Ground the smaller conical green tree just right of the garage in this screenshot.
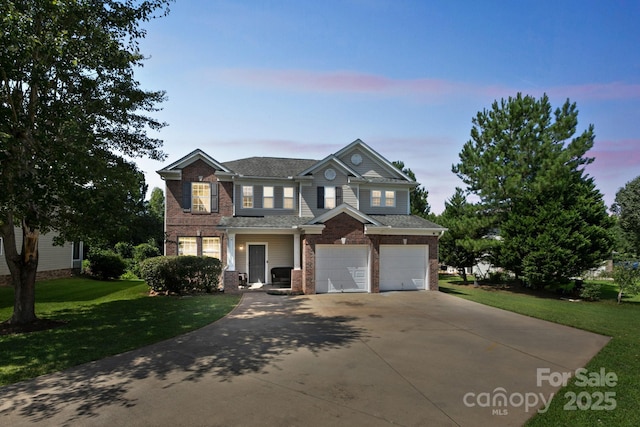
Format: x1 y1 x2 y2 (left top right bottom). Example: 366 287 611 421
437 188 498 283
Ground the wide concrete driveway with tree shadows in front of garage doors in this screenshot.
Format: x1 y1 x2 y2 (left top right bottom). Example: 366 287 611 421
0 291 609 427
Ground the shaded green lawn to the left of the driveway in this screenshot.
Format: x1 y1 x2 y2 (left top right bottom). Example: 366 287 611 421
0 277 240 385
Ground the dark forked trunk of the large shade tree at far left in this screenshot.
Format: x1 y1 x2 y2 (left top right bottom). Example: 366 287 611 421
0 218 39 324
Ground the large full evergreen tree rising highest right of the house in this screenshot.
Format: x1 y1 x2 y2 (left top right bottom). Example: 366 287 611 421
452 94 612 286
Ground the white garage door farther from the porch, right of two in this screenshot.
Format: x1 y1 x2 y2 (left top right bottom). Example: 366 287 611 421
380 245 429 291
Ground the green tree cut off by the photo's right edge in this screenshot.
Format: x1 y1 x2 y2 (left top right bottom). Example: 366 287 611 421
611 176 640 255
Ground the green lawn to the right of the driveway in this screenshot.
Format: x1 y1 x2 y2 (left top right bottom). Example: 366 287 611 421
440 277 640 426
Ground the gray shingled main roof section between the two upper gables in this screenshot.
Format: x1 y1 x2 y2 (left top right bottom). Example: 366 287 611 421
223 157 318 178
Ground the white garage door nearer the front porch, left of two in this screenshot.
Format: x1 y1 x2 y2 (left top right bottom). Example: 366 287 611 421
316 245 369 294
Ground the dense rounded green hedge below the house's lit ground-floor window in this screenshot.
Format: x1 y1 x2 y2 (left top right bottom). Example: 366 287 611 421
140 255 222 295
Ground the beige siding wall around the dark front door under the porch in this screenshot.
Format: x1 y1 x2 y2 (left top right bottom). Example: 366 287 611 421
236 234 294 282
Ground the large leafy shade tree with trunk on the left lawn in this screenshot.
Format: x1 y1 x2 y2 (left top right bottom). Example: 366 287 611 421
0 0 169 324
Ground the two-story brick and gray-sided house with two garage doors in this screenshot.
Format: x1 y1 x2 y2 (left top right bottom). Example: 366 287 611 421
158 140 445 294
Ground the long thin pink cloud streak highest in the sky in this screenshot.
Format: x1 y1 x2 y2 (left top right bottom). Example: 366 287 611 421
213 68 640 100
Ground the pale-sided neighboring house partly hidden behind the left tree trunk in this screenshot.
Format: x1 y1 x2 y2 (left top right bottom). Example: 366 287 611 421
0 228 83 286
